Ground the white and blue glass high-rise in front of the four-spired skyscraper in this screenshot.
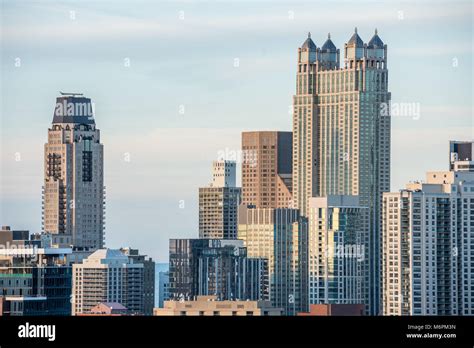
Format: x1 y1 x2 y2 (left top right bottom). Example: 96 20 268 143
308 196 369 307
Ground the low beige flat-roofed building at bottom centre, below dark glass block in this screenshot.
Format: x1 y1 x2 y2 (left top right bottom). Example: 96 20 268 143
153 296 283 316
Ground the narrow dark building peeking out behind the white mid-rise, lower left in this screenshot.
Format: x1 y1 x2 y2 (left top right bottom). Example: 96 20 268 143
120 248 155 315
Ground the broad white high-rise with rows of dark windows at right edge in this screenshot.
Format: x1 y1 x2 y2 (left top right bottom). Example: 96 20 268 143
382 163 474 315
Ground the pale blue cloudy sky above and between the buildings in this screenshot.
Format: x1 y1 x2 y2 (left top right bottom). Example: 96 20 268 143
0 0 474 262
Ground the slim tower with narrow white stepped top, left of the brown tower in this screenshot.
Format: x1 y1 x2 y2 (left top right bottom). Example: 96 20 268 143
199 161 240 239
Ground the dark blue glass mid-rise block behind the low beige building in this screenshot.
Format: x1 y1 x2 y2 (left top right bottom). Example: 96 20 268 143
169 239 269 300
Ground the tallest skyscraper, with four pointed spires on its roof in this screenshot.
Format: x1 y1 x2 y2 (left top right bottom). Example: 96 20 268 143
293 29 390 314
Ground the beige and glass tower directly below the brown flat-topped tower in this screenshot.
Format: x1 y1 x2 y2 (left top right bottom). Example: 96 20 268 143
238 205 308 315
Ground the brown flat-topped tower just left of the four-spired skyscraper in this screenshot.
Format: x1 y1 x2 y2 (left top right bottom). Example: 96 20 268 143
242 131 293 208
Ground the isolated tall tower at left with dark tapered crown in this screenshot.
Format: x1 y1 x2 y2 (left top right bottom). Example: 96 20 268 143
43 94 105 249
